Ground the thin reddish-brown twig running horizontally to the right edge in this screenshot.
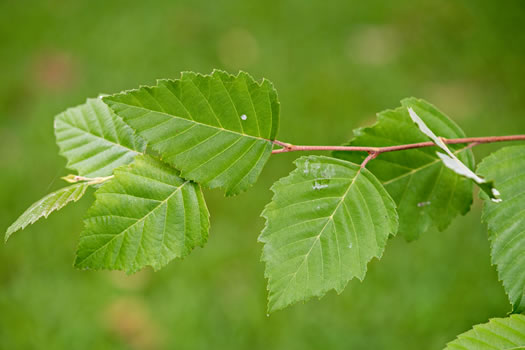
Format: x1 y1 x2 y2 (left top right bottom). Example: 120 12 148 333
272 135 525 154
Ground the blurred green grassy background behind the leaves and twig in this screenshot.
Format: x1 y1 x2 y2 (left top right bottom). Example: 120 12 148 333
0 0 525 350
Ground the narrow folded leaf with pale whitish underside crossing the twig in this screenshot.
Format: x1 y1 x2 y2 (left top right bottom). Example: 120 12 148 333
408 107 500 202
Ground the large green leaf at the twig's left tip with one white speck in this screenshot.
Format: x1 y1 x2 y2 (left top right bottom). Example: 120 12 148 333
104 71 279 195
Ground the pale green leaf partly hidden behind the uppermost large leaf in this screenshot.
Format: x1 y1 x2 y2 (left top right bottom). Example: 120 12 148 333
55 98 146 177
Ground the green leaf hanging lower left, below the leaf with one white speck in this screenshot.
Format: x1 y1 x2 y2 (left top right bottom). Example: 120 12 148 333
75 155 209 273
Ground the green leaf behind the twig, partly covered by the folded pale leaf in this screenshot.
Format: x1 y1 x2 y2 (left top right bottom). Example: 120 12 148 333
334 98 474 241
